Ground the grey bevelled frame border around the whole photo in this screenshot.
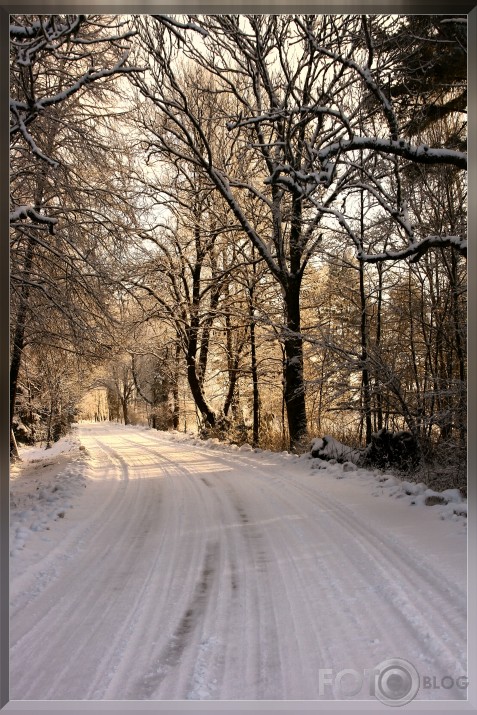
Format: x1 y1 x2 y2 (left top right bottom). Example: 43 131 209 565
0 0 477 715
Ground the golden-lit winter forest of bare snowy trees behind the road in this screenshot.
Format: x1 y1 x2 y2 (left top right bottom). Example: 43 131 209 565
10 14 467 491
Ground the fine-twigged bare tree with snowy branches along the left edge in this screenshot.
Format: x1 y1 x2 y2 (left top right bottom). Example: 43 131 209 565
10 16 143 456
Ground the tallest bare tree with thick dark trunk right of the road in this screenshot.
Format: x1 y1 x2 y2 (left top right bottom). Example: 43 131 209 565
130 16 360 447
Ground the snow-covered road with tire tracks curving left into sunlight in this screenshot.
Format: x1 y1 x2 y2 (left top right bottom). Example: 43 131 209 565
11 424 466 700
